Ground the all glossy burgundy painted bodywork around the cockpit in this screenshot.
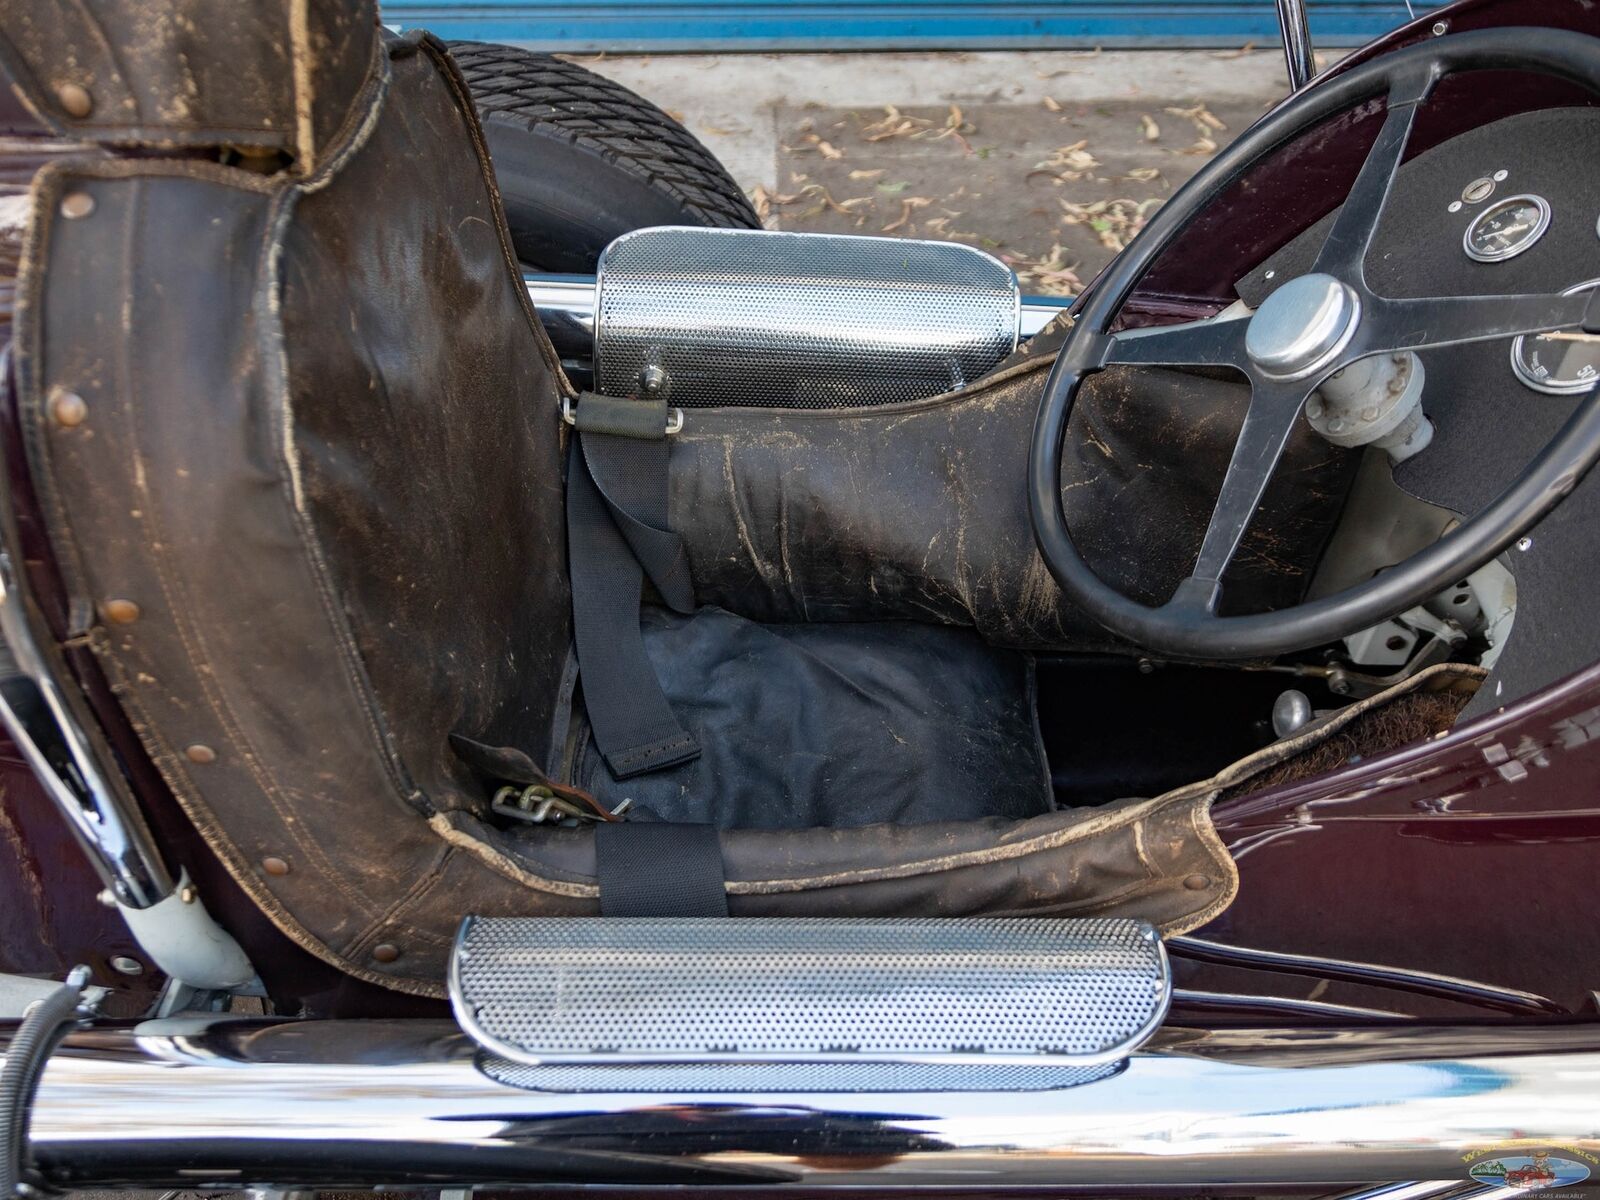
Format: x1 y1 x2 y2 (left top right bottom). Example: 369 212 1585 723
0 0 1600 1016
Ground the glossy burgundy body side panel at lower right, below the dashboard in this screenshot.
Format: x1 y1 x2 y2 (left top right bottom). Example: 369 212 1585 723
1203 666 1600 1014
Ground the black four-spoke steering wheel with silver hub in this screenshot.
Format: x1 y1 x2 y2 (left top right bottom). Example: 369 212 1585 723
1027 29 1600 659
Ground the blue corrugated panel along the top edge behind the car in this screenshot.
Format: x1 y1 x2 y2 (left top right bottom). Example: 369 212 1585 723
382 0 1432 51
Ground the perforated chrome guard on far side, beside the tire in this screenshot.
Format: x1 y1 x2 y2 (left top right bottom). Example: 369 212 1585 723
595 227 1021 408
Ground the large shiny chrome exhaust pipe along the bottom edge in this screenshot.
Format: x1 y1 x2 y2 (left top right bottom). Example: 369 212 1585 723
18 1018 1600 1195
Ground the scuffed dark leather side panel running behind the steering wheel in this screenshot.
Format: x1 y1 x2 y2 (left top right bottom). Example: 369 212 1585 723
672 358 1358 650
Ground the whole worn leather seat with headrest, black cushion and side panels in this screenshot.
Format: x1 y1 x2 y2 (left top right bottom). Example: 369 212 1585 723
0 0 1305 995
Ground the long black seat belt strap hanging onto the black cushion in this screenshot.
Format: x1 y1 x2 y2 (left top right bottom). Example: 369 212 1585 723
566 395 699 779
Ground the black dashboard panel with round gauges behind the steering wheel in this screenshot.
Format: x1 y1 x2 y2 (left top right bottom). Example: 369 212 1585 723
1238 109 1600 717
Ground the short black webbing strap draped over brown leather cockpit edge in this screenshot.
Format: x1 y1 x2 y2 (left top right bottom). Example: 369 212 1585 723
595 821 728 917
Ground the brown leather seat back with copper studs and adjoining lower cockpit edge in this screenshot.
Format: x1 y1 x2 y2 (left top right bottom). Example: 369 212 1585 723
16 16 1234 995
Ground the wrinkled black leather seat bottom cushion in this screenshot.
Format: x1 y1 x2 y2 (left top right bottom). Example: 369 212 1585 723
576 608 1051 829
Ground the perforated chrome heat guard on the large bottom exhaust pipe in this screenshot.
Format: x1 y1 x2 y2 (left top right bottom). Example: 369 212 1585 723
450 917 1171 1091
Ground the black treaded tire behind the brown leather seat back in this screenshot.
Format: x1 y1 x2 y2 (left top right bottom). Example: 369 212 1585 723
450 42 762 274
